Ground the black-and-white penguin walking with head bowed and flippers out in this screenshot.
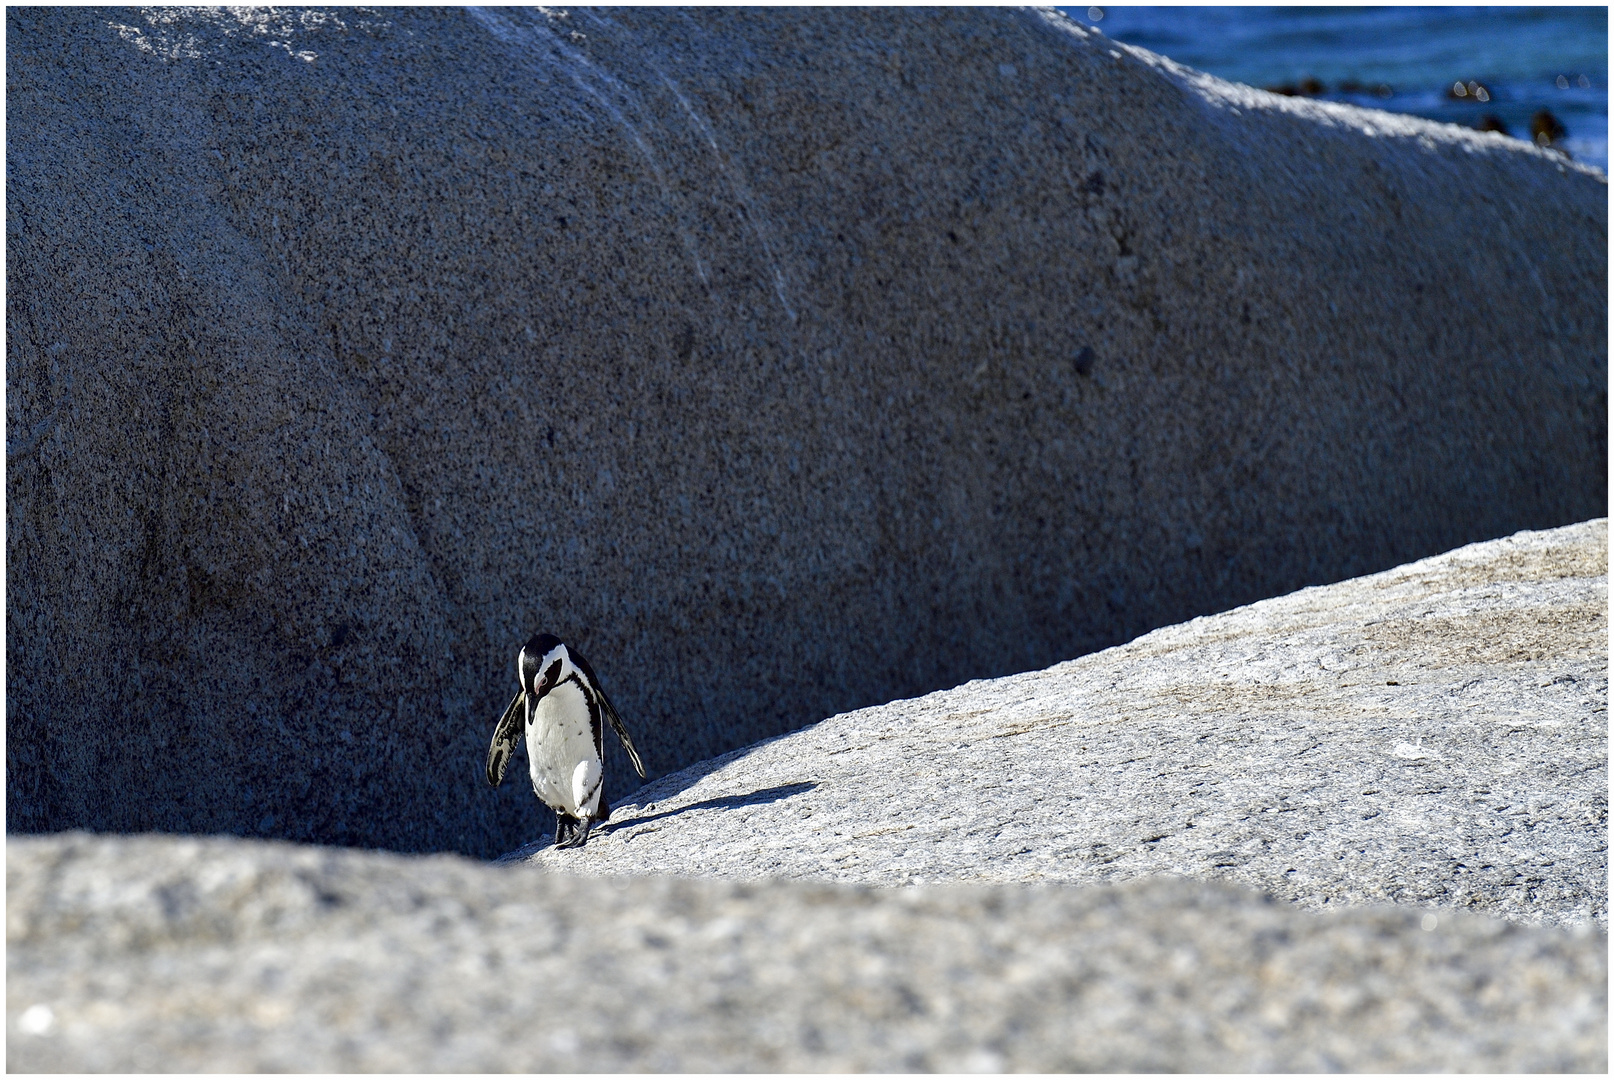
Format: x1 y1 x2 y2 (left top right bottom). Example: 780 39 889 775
487 634 644 848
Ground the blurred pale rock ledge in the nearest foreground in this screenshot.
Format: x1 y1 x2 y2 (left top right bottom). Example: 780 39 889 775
6 835 1608 1072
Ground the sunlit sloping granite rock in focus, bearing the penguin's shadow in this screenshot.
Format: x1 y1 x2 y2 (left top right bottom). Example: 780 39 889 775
512 520 1608 927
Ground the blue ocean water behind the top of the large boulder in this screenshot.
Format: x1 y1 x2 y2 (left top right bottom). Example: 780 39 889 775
1060 5 1609 171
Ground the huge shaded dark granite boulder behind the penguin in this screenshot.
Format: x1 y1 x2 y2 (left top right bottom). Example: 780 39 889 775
6 10 1606 854
